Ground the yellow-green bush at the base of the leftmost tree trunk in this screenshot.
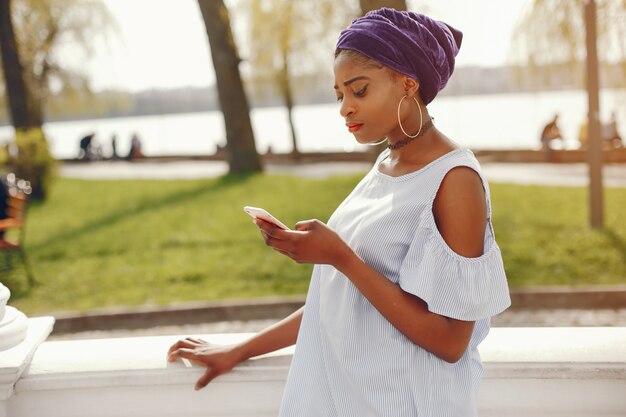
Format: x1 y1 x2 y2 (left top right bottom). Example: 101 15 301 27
0 129 56 200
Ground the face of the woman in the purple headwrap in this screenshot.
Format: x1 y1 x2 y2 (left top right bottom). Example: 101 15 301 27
334 53 404 144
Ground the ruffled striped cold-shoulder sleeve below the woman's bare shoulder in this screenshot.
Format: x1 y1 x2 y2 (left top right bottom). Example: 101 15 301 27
399 211 511 321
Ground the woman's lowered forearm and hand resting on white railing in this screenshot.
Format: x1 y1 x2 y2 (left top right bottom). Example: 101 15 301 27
168 307 304 390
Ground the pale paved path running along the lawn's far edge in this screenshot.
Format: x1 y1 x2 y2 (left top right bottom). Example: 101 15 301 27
61 160 626 187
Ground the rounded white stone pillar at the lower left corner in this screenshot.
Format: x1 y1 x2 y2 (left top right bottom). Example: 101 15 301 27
0 283 54 417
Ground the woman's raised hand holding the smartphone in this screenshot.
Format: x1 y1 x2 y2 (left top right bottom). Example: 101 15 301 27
255 219 352 267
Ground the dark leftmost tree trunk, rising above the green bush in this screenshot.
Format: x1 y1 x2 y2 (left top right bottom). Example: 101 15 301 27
0 0 43 129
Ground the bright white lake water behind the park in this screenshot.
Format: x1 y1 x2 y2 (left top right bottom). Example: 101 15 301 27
0 90 626 158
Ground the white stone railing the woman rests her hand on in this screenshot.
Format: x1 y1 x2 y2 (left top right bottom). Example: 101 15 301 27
0 319 626 417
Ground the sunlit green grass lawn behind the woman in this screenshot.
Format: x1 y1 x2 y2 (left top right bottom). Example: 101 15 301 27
0 174 626 315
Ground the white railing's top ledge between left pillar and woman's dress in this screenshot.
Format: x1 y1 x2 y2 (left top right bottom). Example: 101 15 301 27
17 333 293 392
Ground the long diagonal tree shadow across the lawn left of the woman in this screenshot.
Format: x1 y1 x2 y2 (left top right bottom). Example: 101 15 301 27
27 173 262 251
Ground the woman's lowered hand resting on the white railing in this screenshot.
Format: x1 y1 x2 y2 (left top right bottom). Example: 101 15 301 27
167 337 241 390
